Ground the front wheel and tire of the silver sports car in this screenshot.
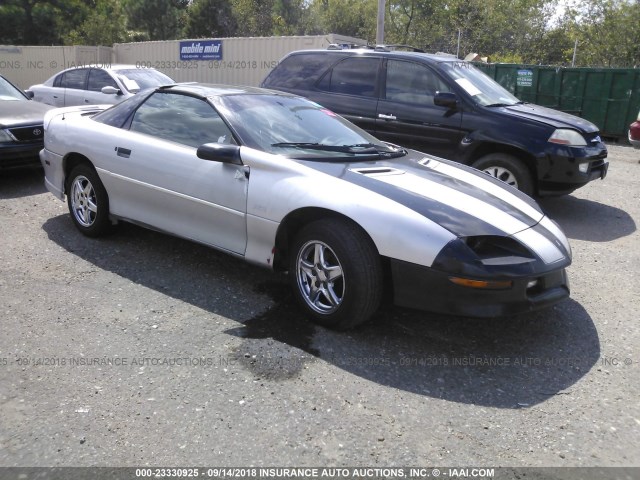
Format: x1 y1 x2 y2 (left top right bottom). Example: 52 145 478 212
289 218 383 330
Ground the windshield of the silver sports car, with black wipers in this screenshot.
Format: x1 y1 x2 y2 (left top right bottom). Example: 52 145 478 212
219 95 405 160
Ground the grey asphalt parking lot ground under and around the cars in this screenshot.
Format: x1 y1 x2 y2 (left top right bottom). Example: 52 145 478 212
0 145 640 467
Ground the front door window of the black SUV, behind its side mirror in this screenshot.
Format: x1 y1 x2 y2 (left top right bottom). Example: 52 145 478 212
385 60 450 105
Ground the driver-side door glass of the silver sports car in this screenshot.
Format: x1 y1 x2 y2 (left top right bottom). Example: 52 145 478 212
131 92 236 148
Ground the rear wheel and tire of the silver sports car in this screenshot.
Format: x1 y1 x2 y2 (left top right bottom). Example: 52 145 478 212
67 164 113 237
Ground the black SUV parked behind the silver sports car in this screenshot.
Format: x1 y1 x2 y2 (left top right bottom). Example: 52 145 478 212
261 47 609 196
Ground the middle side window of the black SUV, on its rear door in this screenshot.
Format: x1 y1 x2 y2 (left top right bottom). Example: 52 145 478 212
318 57 380 97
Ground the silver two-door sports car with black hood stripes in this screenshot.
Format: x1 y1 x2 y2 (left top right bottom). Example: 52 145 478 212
40 84 571 328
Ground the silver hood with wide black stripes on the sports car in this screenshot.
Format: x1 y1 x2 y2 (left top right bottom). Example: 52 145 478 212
300 151 544 237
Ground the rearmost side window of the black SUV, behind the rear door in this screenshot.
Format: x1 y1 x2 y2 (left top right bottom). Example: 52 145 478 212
263 52 338 89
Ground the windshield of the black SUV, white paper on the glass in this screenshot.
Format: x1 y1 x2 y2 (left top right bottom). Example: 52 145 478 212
439 62 522 107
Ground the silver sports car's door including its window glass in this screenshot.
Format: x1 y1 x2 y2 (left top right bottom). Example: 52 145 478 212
101 91 248 254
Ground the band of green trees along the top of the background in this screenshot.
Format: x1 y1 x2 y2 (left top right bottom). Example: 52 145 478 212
0 0 640 67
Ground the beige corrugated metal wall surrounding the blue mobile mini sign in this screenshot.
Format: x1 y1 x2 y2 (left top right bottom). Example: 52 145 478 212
0 34 366 89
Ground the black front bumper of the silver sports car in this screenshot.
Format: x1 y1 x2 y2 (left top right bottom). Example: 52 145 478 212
391 259 569 317
